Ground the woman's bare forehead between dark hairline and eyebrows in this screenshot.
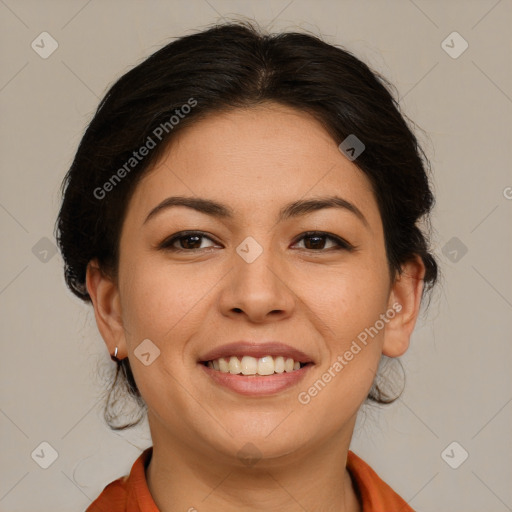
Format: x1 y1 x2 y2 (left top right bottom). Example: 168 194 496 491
124 103 379 226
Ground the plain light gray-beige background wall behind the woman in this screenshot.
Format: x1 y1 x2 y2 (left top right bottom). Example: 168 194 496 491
0 0 512 512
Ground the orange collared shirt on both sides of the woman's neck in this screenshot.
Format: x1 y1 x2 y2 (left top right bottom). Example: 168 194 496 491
85 446 414 512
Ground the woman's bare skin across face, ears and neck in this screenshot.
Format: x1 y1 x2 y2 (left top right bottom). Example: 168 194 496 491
87 103 425 512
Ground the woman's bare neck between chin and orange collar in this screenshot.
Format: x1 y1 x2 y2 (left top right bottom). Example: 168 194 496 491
146 419 362 512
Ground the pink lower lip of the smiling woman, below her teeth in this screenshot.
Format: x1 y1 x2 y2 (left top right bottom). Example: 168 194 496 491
199 363 313 396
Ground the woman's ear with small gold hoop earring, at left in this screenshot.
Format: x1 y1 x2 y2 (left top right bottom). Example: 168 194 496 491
85 259 128 359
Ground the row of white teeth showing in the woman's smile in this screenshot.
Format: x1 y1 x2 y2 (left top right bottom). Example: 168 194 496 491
207 356 301 375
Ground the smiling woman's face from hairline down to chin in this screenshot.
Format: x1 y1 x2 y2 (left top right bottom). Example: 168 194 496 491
90 104 418 464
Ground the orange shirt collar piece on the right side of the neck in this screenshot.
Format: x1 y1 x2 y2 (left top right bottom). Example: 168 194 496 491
347 450 414 512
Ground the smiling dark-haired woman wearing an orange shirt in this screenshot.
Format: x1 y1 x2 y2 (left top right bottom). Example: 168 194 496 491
58 23 437 512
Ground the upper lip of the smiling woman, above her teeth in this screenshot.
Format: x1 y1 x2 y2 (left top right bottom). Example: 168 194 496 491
199 341 313 363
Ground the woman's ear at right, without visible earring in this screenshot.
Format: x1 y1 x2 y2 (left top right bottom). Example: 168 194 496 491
382 256 425 357
